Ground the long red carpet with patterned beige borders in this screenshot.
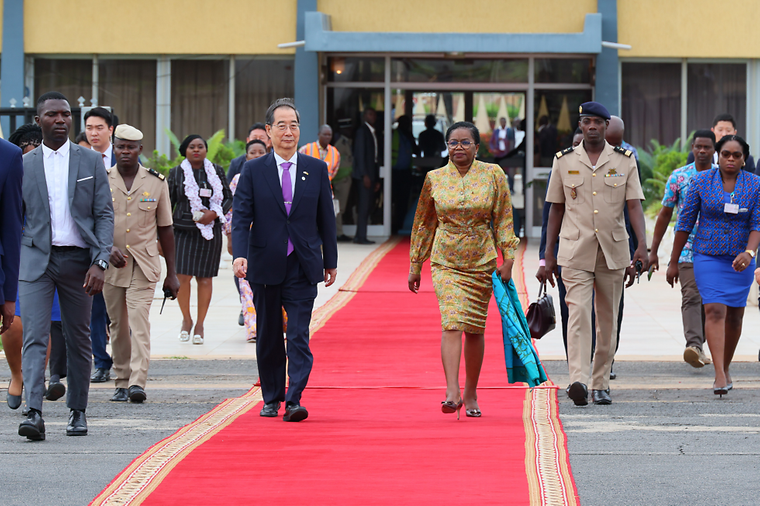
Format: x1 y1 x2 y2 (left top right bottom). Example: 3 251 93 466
93 242 577 505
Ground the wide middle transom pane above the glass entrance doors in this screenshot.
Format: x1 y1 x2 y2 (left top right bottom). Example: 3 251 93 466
391 58 528 83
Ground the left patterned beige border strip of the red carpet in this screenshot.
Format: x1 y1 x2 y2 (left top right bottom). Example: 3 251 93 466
90 238 400 506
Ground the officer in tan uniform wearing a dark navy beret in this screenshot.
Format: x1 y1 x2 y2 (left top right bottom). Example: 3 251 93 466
546 102 648 406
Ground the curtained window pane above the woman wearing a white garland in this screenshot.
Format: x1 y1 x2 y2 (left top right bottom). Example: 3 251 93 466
172 60 229 141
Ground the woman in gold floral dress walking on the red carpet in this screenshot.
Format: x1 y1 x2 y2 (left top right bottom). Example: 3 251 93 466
409 122 519 418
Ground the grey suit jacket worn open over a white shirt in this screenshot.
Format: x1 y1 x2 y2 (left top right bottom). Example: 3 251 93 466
19 143 113 281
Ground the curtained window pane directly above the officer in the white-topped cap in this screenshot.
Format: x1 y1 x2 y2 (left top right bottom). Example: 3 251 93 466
98 60 156 157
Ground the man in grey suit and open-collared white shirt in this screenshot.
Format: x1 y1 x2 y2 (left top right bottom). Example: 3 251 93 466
18 92 113 440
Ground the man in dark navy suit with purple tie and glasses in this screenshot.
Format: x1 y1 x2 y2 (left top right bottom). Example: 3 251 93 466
232 98 338 422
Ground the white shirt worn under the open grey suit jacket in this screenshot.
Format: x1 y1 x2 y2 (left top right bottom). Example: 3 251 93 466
42 141 87 248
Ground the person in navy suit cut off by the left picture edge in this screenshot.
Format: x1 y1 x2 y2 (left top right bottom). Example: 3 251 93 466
0 139 24 336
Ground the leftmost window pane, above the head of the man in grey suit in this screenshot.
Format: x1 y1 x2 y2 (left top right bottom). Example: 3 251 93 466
34 58 92 107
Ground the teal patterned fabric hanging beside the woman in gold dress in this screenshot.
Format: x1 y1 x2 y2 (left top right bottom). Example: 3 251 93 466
492 271 547 387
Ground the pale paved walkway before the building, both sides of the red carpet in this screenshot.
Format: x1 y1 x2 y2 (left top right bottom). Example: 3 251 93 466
151 238 760 361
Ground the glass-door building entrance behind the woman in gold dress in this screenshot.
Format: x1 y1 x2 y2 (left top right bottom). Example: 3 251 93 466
323 54 594 237
